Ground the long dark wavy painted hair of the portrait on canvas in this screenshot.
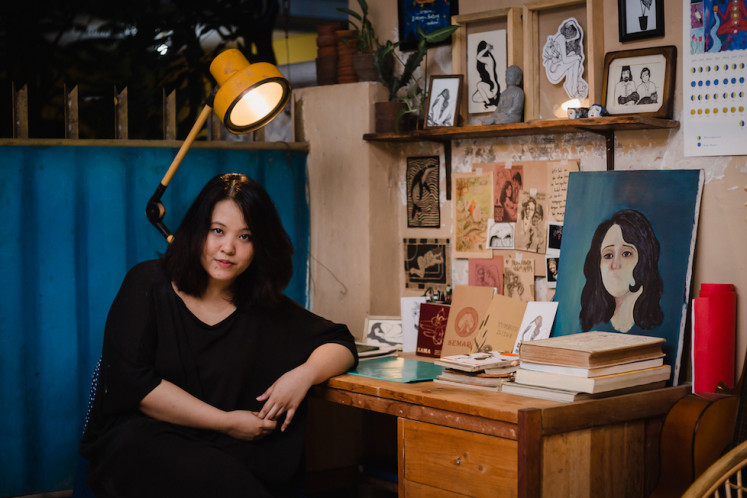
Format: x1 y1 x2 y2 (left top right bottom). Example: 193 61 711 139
579 209 664 331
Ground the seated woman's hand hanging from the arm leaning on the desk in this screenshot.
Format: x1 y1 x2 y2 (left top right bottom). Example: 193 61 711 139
257 364 313 431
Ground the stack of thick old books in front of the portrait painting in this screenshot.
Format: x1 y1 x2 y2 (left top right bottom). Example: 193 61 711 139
502 332 671 401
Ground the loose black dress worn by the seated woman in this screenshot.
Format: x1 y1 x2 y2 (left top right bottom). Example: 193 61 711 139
81 260 357 497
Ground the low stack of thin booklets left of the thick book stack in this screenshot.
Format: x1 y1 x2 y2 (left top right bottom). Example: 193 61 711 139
434 352 519 391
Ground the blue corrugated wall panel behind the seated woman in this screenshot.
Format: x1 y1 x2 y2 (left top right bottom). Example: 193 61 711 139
0 146 309 496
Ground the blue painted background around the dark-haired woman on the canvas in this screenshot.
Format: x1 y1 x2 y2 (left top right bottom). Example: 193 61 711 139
552 170 702 384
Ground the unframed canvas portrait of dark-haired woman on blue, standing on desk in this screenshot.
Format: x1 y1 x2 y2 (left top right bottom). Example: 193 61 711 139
552 170 703 383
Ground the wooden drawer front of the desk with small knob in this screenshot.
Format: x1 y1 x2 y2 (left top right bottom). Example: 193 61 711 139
399 419 518 497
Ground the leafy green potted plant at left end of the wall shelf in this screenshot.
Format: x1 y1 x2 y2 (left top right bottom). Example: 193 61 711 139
374 25 459 133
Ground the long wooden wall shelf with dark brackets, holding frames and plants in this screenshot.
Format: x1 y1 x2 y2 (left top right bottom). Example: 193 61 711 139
363 115 680 199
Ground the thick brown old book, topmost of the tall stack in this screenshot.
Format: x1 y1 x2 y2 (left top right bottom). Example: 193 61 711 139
519 331 664 368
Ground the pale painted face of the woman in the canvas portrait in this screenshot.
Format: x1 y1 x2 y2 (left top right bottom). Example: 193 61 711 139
599 225 638 297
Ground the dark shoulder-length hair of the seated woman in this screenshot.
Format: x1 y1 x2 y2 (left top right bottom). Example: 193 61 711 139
163 173 293 306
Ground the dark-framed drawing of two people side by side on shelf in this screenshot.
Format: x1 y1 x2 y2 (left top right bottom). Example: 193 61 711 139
602 45 677 119
